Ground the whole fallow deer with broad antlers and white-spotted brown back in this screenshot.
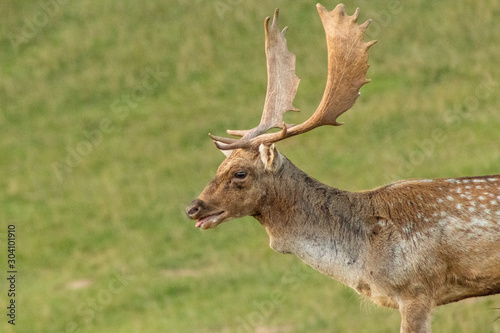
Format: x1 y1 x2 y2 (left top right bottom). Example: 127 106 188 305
186 4 500 333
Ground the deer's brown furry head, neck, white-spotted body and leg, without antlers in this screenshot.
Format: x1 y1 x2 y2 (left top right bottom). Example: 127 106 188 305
186 146 500 332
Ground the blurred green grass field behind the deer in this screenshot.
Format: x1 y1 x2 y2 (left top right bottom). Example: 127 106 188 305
0 0 500 333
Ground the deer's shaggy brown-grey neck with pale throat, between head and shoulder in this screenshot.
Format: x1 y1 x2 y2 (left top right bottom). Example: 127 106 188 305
255 160 365 285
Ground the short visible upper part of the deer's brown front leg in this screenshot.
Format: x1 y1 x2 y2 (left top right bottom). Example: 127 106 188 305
399 298 432 333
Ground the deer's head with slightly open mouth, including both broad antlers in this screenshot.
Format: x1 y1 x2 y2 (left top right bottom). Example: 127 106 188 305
186 4 375 229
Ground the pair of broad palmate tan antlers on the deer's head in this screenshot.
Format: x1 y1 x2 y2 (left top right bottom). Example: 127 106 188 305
210 4 375 150
